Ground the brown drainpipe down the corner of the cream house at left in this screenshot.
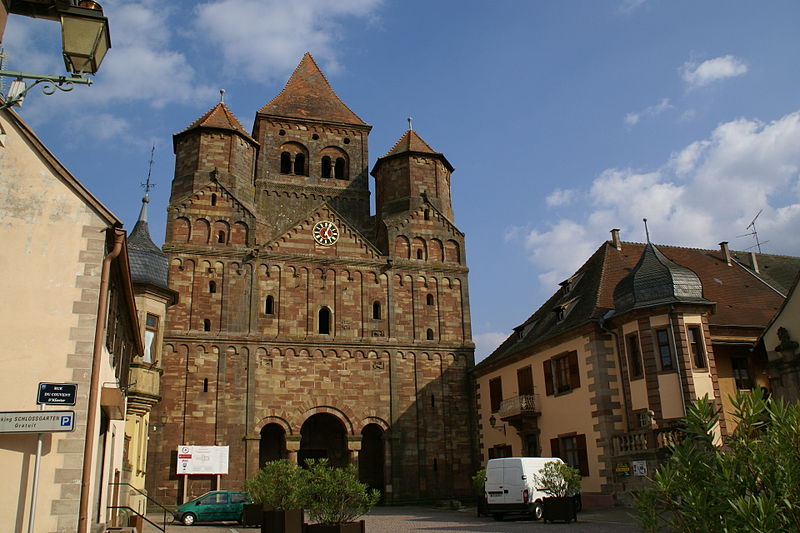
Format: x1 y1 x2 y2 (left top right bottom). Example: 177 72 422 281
78 227 125 533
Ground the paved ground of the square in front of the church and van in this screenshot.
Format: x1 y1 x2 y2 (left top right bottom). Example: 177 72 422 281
143 507 641 533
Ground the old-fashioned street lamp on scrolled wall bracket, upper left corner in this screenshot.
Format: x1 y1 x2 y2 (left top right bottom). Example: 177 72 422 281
0 0 111 109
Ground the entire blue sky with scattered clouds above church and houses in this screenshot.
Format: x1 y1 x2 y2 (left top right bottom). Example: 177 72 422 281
3 0 800 361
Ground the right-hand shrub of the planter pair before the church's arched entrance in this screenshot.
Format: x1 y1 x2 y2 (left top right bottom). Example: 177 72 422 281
301 459 380 533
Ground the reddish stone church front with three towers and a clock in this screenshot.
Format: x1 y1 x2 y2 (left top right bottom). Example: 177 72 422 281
147 54 476 503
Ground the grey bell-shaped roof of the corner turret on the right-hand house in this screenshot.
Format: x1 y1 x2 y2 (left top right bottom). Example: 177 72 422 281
614 242 712 313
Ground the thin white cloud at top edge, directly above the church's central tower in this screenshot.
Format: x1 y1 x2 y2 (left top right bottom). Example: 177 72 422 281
195 0 382 81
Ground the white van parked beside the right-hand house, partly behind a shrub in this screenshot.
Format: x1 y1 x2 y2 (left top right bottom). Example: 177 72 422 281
484 457 580 520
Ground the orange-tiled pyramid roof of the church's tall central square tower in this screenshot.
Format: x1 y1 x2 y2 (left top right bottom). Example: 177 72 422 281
258 52 368 126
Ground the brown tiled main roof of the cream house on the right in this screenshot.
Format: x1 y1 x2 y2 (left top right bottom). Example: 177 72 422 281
475 242 800 371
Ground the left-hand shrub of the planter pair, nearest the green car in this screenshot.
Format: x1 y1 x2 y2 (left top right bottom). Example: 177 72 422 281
243 459 306 533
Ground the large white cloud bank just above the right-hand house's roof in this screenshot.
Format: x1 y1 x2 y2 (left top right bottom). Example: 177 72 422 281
516 111 800 291
